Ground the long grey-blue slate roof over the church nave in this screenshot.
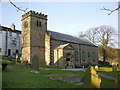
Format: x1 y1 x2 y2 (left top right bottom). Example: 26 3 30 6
47 30 96 47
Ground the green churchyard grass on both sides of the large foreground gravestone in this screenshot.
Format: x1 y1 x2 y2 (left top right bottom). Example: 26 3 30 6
2 60 116 88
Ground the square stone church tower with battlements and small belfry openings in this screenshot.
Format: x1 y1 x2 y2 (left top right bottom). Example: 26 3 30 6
22 11 47 65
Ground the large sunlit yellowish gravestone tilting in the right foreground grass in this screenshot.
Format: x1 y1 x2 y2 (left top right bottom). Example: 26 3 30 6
82 66 101 88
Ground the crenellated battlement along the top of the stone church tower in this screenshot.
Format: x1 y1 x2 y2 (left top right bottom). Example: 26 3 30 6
22 10 47 20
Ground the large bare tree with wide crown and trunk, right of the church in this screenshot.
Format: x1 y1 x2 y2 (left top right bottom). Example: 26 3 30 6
79 25 116 61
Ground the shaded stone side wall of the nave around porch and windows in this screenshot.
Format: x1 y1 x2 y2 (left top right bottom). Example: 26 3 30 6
51 40 98 66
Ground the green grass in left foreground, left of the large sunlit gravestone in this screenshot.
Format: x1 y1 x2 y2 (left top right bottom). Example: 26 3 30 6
2 65 80 88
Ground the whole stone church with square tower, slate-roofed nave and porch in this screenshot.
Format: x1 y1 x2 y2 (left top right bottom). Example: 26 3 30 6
22 11 98 68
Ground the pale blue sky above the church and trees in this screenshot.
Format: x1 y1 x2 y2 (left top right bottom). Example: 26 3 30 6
0 0 118 35
